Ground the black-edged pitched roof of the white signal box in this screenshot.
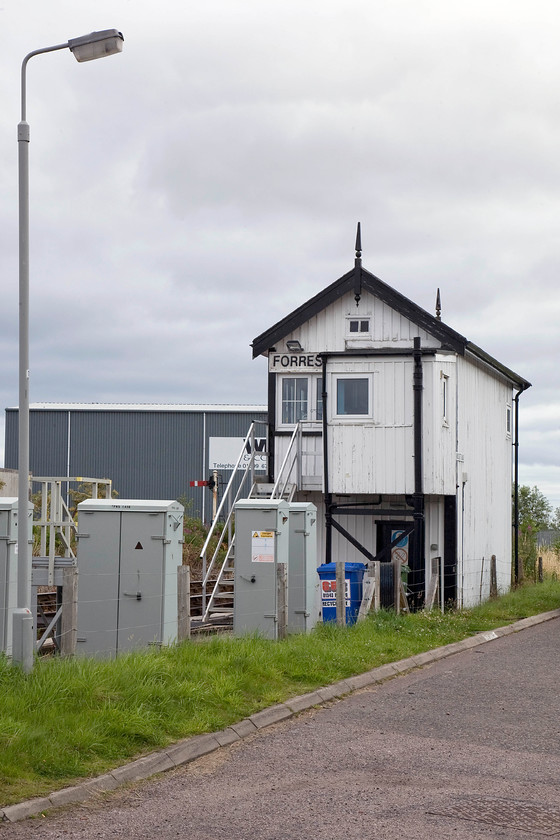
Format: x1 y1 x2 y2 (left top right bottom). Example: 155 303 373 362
252 259 531 390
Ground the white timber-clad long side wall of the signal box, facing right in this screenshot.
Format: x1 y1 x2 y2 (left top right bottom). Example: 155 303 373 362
457 358 512 606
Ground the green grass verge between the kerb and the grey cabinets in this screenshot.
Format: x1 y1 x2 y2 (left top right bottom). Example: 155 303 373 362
0 580 560 805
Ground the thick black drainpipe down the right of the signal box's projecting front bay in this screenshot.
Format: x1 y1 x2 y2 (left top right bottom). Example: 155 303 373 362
411 338 425 609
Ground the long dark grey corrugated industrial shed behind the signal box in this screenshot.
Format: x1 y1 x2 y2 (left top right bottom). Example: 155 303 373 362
5 403 267 519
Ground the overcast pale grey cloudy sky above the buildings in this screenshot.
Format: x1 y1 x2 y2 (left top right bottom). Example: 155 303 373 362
0 0 560 506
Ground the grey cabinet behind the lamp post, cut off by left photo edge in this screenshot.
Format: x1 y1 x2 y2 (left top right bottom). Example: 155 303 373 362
0 497 33 656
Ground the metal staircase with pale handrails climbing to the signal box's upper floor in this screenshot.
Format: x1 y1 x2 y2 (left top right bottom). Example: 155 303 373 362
200 423 301 623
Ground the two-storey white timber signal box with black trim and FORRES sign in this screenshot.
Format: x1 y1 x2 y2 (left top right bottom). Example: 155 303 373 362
252 226 530 608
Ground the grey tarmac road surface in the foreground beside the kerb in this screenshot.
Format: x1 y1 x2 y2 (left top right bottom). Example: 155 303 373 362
0 618 560 840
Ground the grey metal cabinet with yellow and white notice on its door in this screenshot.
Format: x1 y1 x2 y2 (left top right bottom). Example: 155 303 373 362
233 499 289 640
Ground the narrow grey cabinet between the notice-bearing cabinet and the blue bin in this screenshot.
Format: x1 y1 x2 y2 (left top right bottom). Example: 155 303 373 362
288 502 320 633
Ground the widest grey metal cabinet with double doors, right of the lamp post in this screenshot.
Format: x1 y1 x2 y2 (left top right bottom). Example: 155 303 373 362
78 499 184 656
